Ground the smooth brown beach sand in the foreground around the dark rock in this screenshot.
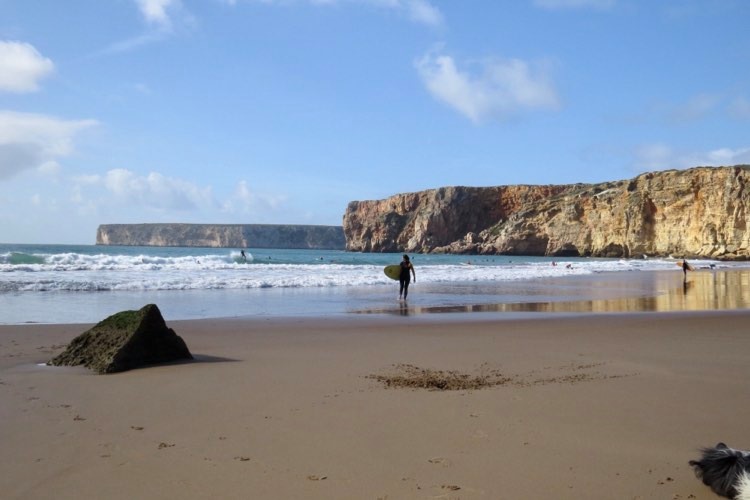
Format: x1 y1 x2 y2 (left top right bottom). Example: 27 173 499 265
0 311 750 500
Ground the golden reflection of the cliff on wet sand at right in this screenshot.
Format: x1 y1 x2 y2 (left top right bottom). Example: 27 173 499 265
355 269 750 315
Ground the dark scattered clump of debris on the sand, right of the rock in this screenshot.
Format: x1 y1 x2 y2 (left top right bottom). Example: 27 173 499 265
367 364 513 391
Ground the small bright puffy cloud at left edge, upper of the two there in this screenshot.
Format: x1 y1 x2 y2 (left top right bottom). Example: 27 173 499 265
0 41 55 93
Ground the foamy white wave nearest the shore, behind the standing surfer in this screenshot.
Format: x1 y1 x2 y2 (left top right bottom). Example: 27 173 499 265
0 260 728 292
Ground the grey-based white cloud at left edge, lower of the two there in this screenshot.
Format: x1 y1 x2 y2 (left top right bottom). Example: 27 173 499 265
0 111 97 179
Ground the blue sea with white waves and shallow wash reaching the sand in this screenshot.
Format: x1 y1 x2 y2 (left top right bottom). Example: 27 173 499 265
0 244 750 325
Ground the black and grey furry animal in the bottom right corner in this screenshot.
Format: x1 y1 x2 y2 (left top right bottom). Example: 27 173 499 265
688 443 750 500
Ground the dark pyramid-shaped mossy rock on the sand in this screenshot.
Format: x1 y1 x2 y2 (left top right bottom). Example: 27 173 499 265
48 304 193 374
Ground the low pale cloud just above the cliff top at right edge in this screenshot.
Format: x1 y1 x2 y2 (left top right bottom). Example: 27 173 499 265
635 144 750 171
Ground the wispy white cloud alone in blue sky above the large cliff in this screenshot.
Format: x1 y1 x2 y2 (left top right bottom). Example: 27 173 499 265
415 49 559 123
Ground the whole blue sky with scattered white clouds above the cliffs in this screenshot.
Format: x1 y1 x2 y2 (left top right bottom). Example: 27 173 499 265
0 0 750 243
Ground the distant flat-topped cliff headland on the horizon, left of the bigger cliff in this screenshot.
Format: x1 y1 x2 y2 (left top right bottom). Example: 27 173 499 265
96 224 345 250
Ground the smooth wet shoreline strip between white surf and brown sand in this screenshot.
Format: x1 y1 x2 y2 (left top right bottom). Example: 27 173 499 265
3 268 750 325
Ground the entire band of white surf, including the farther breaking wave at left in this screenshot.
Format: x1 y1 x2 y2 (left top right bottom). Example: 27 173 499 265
0 249 736 292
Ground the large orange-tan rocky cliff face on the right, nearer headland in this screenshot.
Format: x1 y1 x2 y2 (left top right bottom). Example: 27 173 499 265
344 165 750 259
